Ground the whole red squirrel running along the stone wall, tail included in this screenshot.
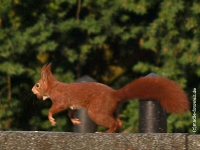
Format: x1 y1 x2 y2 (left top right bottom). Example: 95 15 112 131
32 64 189 133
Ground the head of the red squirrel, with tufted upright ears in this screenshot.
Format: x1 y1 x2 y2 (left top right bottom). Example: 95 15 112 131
32 64 56 100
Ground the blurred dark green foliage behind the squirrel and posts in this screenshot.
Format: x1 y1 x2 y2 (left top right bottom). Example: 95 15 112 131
0 0 200 133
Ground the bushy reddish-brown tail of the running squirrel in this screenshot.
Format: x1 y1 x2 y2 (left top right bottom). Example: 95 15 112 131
117 77 189 113
